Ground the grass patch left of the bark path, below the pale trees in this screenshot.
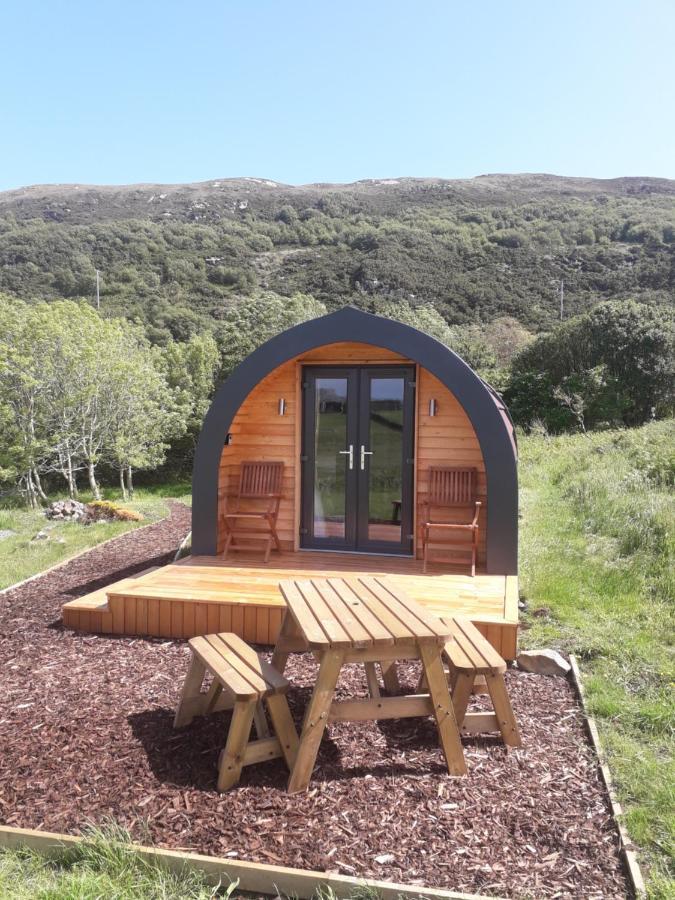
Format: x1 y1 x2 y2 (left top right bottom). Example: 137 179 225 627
0 482 190 590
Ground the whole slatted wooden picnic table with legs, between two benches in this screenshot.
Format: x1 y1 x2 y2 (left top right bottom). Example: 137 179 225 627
272 577 466 792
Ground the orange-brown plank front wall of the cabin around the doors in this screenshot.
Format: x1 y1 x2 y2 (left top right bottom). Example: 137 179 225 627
218 343 487 565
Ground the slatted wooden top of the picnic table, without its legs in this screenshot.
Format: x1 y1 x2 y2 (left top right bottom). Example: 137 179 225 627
279 576 451 650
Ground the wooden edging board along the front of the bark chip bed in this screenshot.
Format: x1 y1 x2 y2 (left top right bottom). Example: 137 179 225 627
0 825 498 900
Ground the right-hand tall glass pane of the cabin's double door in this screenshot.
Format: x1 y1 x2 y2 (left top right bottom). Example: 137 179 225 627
366 378 405 544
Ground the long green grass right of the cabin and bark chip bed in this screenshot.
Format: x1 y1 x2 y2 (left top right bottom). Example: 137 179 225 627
520 420 675 900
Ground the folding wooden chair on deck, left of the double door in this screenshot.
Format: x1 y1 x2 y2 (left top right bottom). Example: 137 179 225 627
222 460 284 562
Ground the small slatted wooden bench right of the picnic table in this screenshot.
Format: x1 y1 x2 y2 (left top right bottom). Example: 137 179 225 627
442 616 521 747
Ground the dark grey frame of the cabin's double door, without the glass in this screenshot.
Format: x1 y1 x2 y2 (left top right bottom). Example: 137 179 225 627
300 364 416 556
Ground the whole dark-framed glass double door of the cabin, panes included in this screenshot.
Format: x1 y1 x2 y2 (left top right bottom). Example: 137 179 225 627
301 366 415 554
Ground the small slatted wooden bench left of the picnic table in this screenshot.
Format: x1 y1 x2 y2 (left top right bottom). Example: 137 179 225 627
173 633 298 791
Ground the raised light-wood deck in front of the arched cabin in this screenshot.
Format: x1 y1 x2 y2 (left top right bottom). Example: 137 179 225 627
63 551 518 659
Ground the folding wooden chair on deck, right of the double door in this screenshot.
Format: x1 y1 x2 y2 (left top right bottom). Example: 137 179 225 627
420 466 481 577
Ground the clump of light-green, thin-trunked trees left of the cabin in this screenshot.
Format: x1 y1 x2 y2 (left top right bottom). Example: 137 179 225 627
0 298 193 506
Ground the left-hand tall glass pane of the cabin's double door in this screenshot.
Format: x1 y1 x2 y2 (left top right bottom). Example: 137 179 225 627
314 378 349 538
